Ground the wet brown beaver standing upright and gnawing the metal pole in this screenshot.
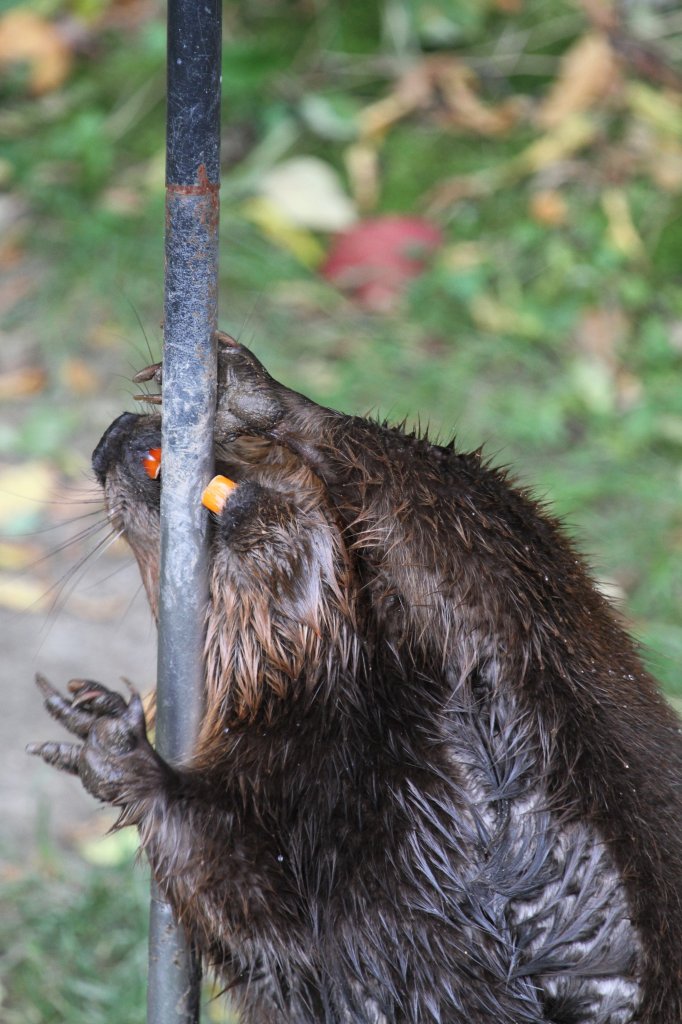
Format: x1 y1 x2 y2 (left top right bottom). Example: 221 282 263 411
31 336 682 1024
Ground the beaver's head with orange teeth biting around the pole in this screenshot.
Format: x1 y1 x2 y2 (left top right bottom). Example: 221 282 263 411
92 413 361 740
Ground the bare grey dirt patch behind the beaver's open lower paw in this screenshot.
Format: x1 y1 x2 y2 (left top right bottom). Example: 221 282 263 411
0 550 156 861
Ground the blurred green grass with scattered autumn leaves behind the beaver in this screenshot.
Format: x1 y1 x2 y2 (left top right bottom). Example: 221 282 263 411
0 0 682 1024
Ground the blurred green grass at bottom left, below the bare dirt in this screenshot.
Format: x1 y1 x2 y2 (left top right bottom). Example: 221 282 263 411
0 844 236 1024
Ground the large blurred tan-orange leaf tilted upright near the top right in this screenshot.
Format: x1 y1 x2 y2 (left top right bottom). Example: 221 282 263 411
538 32 620 128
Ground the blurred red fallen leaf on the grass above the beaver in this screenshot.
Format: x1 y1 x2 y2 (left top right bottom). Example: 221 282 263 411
321 216 442 312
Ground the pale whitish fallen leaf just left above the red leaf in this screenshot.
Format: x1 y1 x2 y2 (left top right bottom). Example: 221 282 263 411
260 157 357 231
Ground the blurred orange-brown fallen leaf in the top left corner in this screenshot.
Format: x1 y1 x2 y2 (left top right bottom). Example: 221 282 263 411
0 7 72 95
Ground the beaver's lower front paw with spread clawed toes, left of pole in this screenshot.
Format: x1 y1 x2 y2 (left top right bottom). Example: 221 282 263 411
27 676 172 806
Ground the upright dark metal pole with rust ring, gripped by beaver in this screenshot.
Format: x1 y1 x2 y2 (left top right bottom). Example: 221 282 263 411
147 0 221 1024
